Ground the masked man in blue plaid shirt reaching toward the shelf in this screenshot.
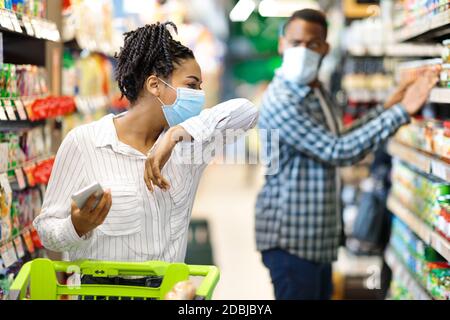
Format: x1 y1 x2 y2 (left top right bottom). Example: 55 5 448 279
255 9 439 299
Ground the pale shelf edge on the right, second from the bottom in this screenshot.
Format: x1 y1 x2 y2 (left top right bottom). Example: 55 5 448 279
387 196 450 261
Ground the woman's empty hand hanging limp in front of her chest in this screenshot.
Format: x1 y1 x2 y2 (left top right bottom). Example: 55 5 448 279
144 126 192 192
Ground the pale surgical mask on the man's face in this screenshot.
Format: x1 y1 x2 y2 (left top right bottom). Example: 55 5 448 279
280 47 322 85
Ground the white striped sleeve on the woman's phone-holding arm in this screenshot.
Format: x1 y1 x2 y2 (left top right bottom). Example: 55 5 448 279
33 131 91 252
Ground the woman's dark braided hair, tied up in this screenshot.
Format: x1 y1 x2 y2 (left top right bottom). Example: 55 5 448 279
115 22 194 103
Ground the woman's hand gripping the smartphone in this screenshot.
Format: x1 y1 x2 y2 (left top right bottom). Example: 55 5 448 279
72 190 112 237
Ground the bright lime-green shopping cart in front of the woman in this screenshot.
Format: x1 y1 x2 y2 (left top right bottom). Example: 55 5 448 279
9 259 219 300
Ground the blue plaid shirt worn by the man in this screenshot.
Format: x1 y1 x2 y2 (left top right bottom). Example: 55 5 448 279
255 74 410 263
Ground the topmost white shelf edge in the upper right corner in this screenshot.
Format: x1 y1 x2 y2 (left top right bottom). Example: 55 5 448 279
394 10 450 42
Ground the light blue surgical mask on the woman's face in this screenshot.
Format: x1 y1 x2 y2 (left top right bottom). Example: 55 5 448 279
157 79 205 127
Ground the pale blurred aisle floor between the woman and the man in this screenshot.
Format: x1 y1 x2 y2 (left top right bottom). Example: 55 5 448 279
193 165 273 300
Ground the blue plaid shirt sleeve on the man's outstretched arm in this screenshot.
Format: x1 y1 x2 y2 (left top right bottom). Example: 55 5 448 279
264 89 410 166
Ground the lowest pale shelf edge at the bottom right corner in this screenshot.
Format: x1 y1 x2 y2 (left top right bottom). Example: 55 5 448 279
384 247 433 300
